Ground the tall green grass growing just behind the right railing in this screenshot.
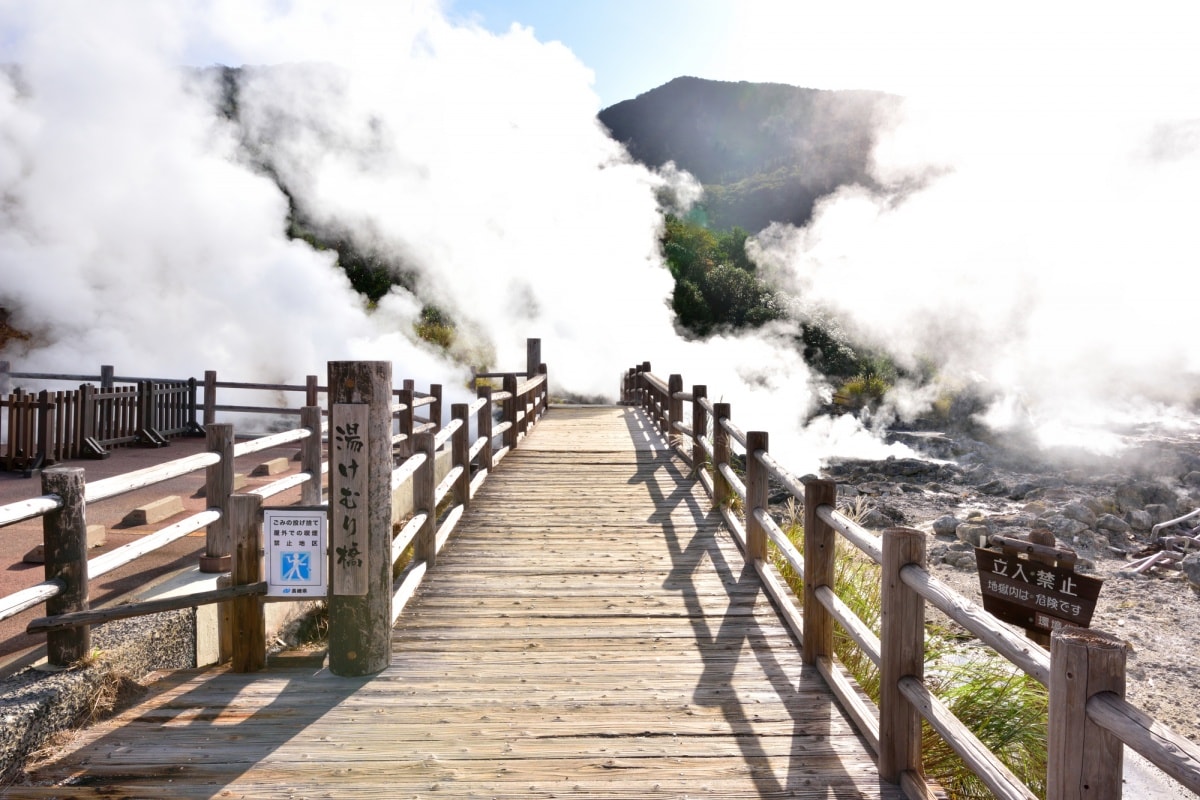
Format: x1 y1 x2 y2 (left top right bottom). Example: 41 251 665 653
775 510 1049 800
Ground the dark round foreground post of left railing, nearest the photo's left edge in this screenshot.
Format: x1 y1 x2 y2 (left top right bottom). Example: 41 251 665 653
42 467 91 667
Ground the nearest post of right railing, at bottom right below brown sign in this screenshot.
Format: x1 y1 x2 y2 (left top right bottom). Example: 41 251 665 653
1046 627 1126 800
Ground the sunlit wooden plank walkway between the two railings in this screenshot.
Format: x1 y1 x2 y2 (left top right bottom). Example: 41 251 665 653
9 408 901 800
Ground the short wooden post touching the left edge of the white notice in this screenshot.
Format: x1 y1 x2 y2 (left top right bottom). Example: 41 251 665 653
229 494 266 672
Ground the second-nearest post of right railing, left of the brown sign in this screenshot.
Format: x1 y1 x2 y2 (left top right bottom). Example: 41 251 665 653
880 528 925 783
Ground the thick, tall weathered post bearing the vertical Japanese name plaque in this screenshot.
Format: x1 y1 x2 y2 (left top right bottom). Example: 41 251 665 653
328 361 393 678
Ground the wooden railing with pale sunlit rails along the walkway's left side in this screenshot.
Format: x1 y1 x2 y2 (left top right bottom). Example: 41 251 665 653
0 342 548 672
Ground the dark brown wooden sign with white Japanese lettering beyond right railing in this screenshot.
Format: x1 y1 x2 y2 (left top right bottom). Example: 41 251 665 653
976 547 1104 633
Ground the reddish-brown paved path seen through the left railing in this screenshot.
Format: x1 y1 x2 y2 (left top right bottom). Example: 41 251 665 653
0 437 309 676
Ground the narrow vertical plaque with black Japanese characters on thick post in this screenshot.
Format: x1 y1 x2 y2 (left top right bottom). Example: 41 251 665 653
329 403 370 595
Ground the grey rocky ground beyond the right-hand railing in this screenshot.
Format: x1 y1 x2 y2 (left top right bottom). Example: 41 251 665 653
826 422 1200 741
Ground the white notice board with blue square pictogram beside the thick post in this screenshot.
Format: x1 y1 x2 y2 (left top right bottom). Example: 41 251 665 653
263 506 329 600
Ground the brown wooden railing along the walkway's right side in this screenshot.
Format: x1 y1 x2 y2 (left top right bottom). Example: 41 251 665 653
620 363 1200 800
